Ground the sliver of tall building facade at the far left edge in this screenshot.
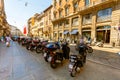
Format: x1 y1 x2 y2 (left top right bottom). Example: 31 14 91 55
0 0 10 36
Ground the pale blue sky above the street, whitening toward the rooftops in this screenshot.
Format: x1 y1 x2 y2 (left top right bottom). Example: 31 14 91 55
4 0 52 32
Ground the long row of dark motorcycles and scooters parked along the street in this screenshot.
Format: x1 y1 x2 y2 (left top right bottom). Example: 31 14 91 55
17 38 93 77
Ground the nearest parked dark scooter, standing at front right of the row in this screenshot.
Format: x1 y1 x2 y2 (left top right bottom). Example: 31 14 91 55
68 45 86 77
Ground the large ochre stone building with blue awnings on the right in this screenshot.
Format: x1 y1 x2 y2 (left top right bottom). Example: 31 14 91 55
52 0 120 44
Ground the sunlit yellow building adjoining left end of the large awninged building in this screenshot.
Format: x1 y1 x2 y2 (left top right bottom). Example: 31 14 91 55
28 5 53 39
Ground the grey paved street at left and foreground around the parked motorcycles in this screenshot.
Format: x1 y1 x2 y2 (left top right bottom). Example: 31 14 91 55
0 42 120 80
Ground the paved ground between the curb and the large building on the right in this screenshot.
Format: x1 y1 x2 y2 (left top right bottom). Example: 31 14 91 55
70 44 120 69
